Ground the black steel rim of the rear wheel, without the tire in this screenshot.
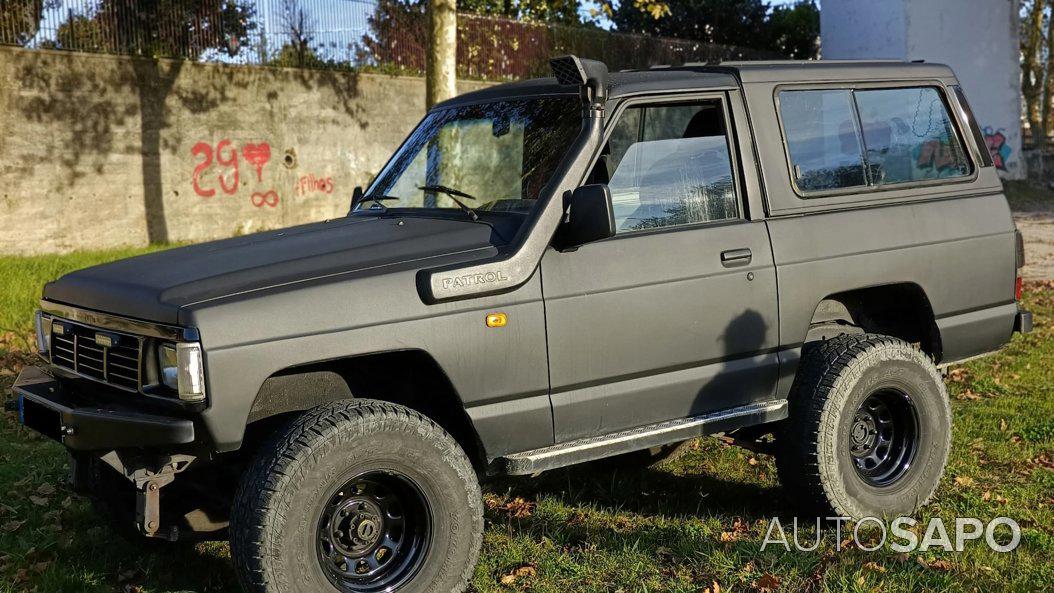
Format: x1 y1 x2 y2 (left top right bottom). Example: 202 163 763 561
848 389 919 488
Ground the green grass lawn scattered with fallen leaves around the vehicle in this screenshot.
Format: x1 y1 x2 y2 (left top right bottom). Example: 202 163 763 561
0 251 1054 593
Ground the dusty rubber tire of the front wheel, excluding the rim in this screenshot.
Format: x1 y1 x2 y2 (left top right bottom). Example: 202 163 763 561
230 400 483 593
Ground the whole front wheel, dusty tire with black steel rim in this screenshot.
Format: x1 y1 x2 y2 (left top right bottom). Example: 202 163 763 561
231 400 483 593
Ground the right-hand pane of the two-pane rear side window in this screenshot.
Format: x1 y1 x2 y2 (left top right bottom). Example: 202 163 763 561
856 86 970 185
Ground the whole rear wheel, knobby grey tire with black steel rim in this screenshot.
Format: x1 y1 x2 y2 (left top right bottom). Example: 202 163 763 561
776 334 952 518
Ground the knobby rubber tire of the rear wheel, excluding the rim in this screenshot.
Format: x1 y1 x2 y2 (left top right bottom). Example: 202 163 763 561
776 334 952 518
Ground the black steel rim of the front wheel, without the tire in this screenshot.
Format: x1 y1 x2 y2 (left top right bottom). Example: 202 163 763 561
317 471 432 593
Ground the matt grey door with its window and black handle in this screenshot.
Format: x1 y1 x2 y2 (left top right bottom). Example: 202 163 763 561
542 95 778 442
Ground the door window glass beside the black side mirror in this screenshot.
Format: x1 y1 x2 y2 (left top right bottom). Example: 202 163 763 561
601 100 739 234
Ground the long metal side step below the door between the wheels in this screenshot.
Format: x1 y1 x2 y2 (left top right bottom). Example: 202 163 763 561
495 399 787 476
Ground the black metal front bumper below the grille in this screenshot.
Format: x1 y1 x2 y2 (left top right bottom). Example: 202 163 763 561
13 367 194 451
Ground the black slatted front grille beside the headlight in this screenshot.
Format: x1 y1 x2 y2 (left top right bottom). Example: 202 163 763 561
52 319 142 392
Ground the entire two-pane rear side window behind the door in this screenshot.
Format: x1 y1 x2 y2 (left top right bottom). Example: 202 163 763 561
779 86 972 193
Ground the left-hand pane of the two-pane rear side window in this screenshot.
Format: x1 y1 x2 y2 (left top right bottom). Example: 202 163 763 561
780 90 867 192
